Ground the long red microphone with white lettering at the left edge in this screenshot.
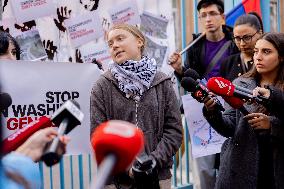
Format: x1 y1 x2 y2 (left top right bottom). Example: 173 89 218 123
2 116 54 154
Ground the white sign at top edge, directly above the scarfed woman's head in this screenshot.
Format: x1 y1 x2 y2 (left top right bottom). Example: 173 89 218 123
109 0 140 25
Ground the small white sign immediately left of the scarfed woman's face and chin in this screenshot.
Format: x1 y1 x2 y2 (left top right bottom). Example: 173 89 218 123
80 42 111 70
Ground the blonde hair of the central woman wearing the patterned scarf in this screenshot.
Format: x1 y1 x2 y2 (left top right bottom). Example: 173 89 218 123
107 24 146 54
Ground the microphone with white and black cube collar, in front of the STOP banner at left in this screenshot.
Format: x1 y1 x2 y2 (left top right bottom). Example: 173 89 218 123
41 100 84 166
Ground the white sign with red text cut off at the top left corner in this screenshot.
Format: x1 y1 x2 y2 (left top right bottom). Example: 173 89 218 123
11 0 56 23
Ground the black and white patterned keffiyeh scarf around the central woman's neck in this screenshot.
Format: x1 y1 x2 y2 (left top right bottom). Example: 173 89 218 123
110 56 157 101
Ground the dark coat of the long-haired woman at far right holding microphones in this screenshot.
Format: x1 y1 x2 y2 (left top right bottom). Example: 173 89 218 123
203 77 284 189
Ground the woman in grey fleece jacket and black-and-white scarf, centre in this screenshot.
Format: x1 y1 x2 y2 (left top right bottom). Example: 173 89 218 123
91 24 182 188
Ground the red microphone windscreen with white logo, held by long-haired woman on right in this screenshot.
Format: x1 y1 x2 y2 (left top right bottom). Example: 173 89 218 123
207 77 235 96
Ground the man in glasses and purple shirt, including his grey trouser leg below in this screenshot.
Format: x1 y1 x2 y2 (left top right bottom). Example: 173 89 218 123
168 0 239 189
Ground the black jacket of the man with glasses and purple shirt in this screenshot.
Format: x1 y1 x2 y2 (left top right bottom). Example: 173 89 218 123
175 26 239 80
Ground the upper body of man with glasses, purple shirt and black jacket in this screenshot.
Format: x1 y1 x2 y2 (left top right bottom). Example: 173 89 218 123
169 0 239 79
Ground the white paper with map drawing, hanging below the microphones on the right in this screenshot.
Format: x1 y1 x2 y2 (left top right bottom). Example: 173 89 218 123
182 94 226 158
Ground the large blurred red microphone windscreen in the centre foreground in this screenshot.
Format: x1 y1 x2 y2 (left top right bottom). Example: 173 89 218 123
91 120 144 174
